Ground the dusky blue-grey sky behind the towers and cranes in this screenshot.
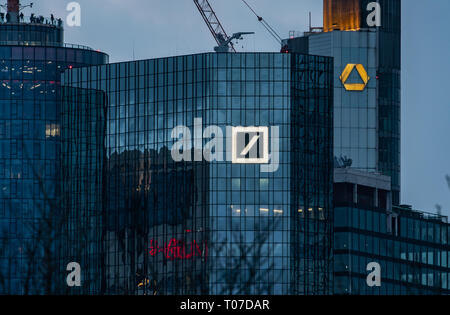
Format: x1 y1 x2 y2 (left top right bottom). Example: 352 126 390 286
29 0 450 216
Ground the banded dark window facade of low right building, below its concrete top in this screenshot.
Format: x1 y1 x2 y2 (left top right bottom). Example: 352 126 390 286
334 207 450 295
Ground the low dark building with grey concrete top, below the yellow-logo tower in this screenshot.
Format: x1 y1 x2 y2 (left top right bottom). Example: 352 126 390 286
334 169 450 295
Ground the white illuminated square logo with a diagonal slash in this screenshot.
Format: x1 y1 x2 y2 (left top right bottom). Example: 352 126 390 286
231 127 269 164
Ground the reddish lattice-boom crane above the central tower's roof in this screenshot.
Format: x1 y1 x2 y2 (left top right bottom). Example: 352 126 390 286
193 0 255 52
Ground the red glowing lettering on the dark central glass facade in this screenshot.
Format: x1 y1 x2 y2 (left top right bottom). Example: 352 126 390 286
149 238 208 260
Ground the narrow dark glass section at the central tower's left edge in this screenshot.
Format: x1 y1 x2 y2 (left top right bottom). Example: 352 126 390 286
59 87 106 294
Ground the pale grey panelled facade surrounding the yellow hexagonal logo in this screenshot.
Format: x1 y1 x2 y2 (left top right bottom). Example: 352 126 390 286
309 31 378 172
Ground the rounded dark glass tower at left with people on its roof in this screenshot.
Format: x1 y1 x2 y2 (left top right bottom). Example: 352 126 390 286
0 1 108 294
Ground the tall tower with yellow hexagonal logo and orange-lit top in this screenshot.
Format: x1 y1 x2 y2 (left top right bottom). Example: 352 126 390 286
286 0 401 205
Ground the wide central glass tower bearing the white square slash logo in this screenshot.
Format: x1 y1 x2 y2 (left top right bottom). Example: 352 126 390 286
62 53 333 294
